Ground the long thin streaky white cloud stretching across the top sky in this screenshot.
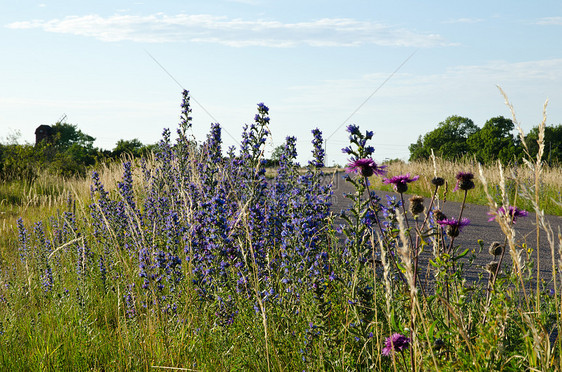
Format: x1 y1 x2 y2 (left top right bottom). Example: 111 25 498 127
6 13 451 47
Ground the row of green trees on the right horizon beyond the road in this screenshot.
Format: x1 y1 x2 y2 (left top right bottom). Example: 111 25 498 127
408 116 562 164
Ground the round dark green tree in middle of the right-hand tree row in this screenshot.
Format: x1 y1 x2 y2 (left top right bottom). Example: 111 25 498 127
467 116 521 164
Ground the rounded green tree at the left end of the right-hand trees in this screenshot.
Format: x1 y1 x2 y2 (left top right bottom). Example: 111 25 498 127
408 116 478 160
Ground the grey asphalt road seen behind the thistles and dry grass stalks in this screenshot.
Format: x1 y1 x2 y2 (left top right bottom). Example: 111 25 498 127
326 173 562 283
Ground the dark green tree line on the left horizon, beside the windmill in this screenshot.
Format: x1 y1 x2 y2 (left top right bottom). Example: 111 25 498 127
0 122 154 181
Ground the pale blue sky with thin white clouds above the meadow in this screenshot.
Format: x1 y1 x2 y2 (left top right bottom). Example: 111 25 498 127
0 0 562 165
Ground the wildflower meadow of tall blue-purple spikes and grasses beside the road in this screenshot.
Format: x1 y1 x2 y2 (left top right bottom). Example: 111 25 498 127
0 92 562 371
